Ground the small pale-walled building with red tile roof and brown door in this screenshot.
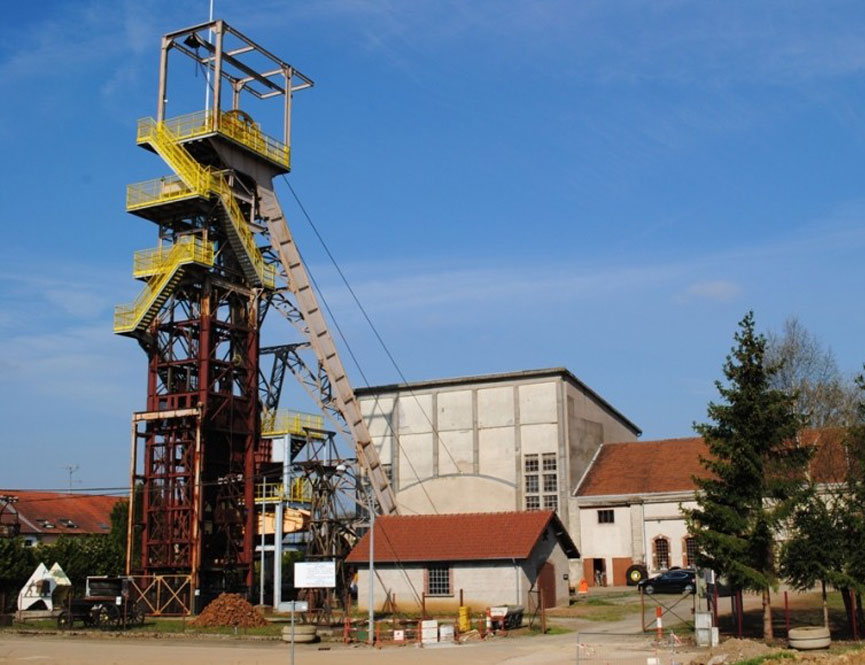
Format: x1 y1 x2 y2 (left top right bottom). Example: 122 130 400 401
346 510 579 612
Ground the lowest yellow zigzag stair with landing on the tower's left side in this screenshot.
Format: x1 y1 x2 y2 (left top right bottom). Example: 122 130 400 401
114 236 213 335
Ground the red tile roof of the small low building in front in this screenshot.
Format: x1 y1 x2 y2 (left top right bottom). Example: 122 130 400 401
346 510 579 563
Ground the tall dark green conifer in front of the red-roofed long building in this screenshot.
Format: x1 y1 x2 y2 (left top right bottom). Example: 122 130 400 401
684 312 809 640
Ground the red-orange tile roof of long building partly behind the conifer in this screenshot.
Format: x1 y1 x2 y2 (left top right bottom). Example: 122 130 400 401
576 428 845 496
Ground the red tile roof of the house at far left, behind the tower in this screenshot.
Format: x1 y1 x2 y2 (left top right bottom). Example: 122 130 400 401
0 489 126 535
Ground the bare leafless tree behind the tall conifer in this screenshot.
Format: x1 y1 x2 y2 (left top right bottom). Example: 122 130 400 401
766 316 857 427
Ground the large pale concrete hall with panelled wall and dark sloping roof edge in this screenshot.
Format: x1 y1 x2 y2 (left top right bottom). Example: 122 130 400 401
356 368 641 577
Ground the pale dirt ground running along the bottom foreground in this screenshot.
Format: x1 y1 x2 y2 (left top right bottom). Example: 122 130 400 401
0 590 865 665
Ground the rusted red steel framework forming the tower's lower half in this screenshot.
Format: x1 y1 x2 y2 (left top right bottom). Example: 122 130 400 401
135 270 260 600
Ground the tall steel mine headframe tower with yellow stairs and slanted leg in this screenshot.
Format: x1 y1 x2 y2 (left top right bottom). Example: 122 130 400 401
114 20 396 604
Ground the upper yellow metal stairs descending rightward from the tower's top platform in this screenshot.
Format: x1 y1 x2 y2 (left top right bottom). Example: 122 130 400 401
137 118 276 288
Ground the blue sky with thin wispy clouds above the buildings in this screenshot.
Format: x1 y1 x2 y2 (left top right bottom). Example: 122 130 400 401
0 0 865 488
